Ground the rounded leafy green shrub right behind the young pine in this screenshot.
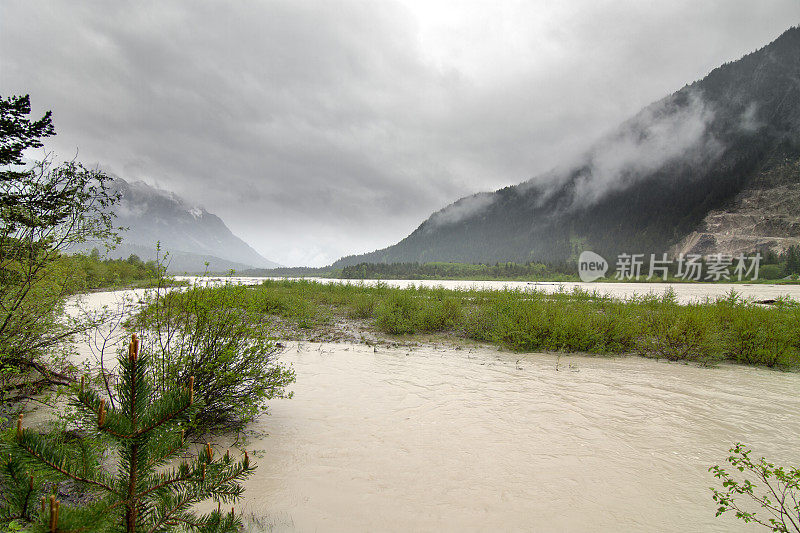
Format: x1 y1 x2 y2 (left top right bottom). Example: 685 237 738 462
135 285 295 429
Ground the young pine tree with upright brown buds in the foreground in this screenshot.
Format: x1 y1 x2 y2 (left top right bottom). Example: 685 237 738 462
0 335 255 533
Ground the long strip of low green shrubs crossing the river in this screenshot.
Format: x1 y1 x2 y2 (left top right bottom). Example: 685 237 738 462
159 280 800 369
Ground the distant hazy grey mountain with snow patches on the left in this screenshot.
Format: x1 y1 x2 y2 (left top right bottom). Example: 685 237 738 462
100 178 279 272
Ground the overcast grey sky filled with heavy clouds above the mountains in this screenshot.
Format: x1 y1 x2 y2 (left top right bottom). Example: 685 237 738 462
0 0 800 266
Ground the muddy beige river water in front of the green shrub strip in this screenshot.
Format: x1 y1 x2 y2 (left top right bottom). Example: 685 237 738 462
69 286 800 532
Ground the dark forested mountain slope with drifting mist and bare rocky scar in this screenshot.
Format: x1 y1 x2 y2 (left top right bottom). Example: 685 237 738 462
333 27 800 267
